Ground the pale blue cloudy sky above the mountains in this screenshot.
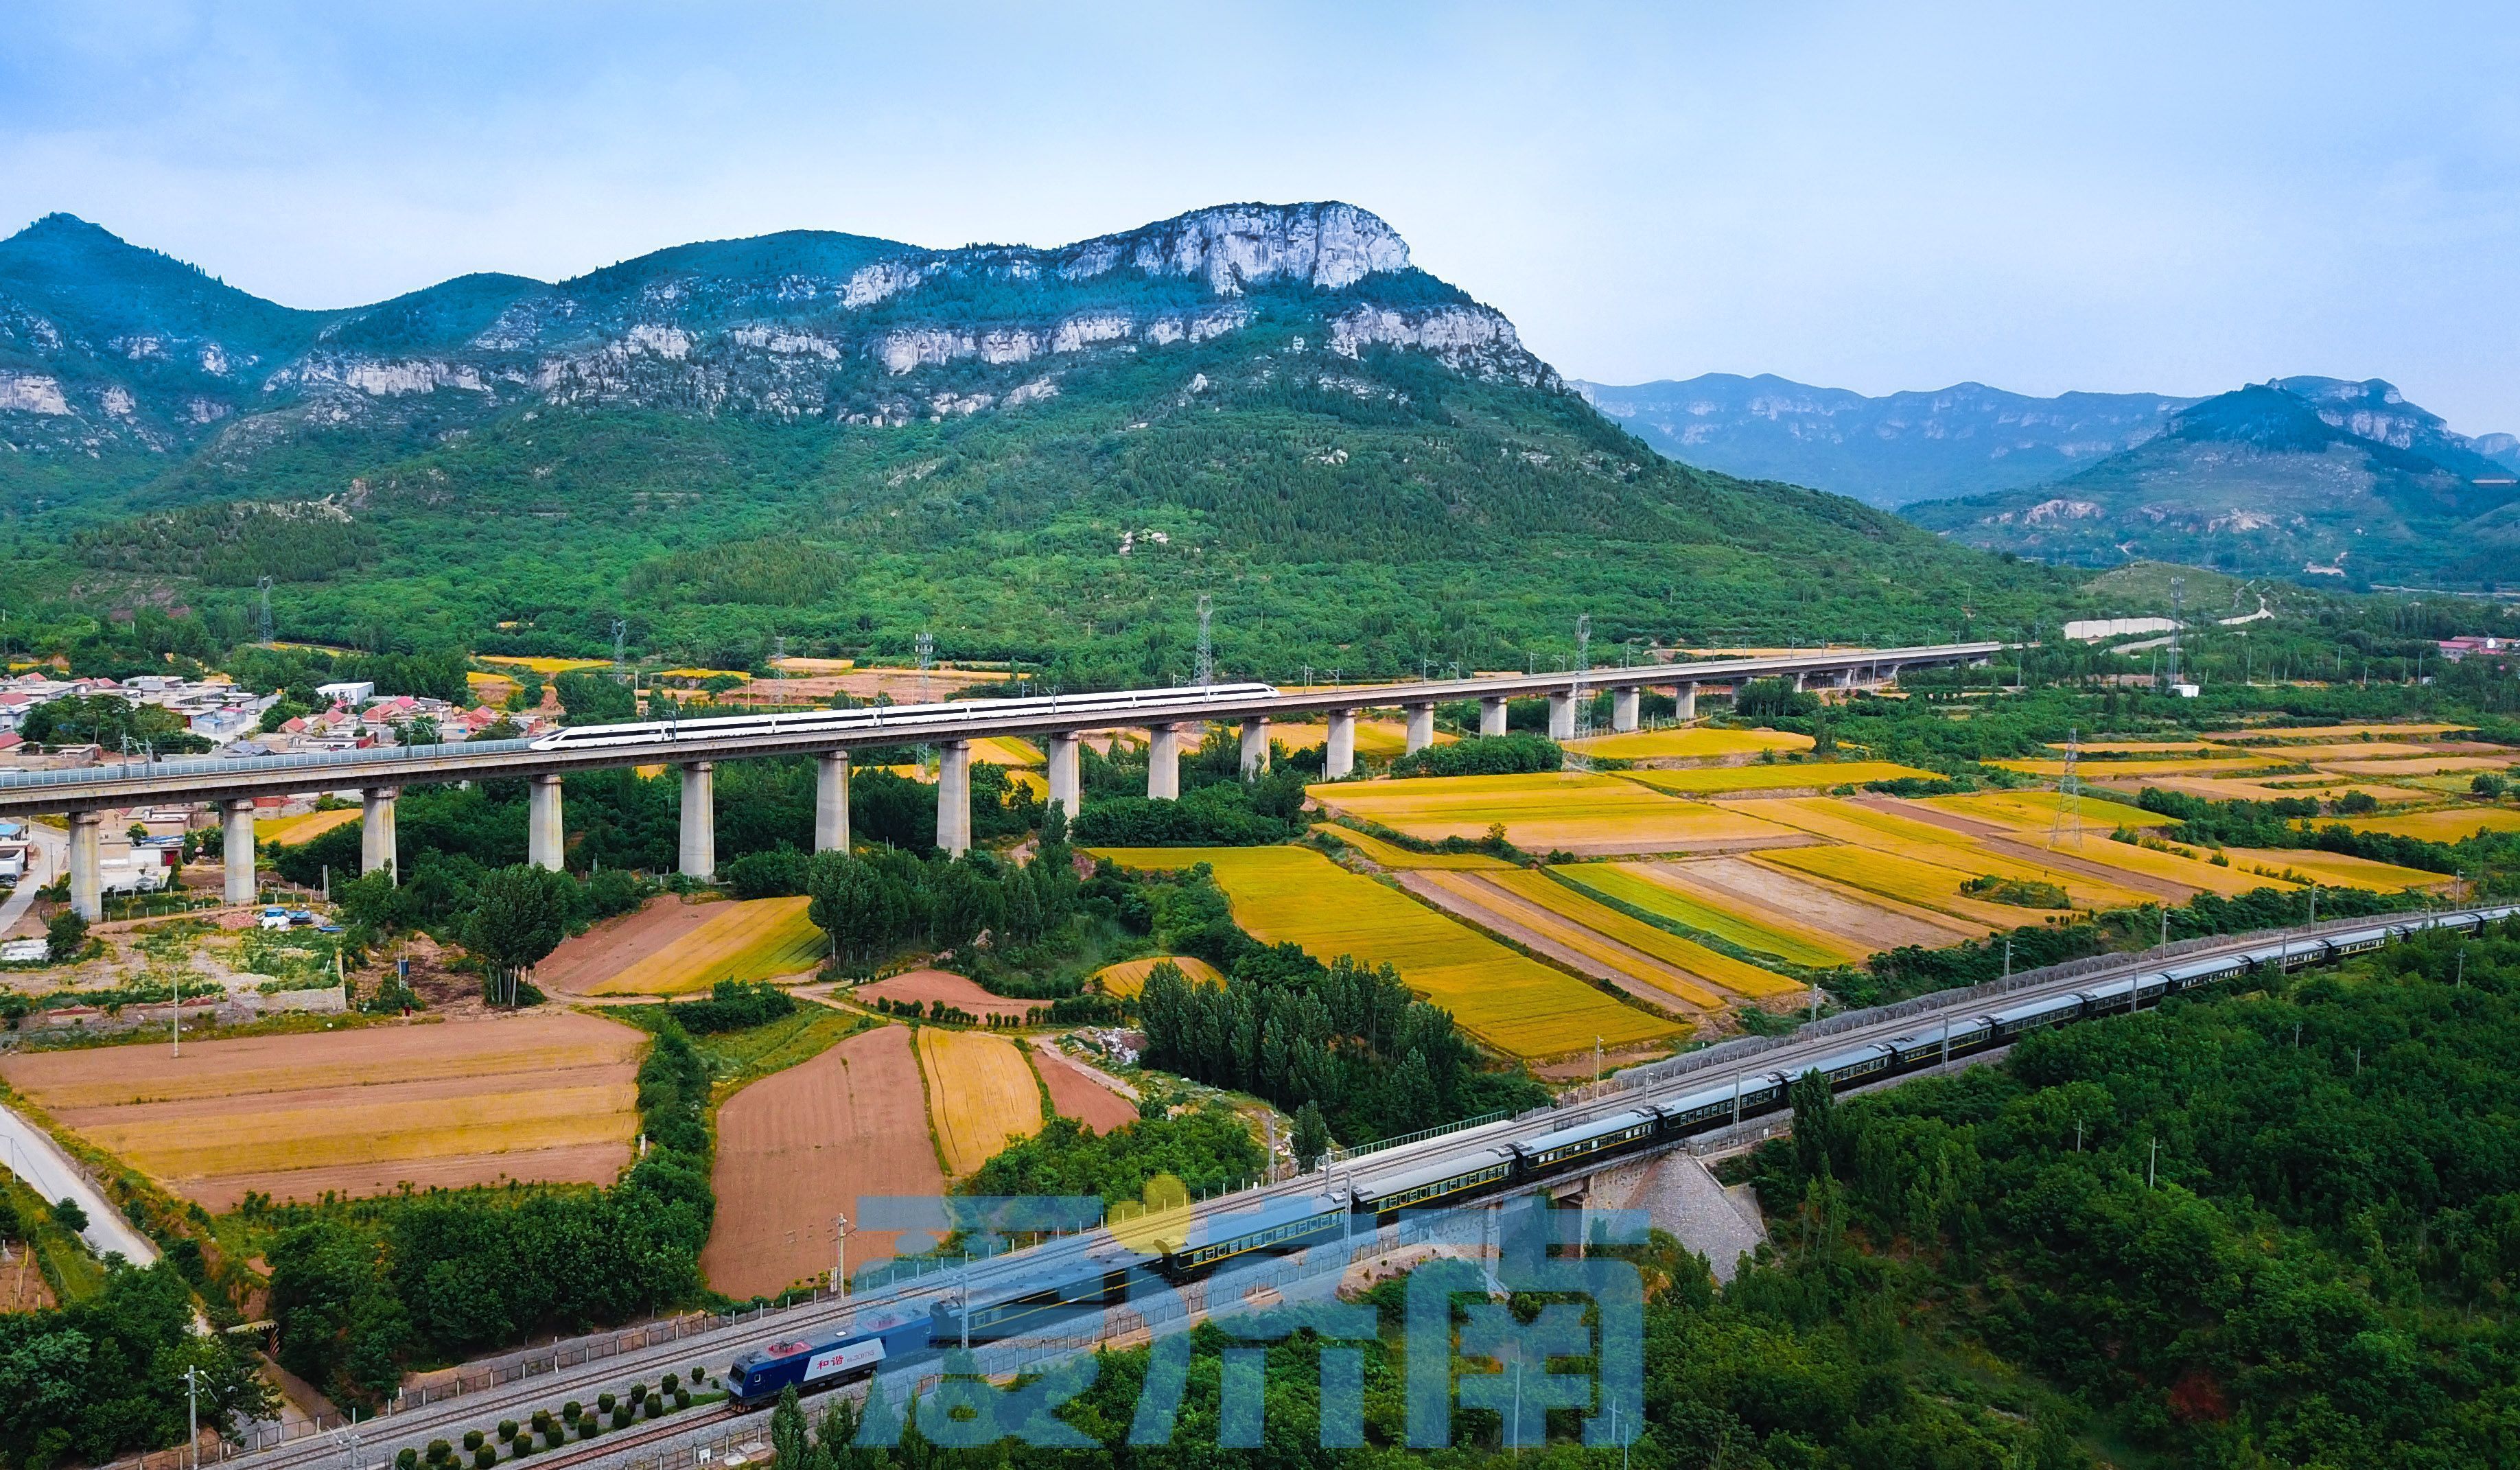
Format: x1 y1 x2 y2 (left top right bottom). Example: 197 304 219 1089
14 0 2520 434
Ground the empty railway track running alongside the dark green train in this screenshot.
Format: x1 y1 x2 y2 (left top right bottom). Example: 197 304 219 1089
207 905 2520 1470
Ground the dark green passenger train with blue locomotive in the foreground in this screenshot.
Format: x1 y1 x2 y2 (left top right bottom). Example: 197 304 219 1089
728 905 2520 1410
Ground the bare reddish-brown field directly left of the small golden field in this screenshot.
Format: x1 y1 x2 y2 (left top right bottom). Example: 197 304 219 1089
701 1026 945 1296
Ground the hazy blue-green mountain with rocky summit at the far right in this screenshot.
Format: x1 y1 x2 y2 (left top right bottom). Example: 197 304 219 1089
1905 378 2520 587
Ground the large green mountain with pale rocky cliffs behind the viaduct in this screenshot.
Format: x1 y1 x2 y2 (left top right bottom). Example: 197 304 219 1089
0 202 2069 684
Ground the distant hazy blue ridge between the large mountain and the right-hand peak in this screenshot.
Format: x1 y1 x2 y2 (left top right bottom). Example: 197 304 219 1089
1575 373 2195 506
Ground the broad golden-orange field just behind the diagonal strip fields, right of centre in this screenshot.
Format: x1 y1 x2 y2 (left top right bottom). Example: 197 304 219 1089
1310 771 1799 857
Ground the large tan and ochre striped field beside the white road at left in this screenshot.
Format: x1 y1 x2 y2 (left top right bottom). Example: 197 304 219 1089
0 1009 645 1211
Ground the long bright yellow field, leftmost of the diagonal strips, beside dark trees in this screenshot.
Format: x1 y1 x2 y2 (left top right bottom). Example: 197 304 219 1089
1094 847 1681 1056
